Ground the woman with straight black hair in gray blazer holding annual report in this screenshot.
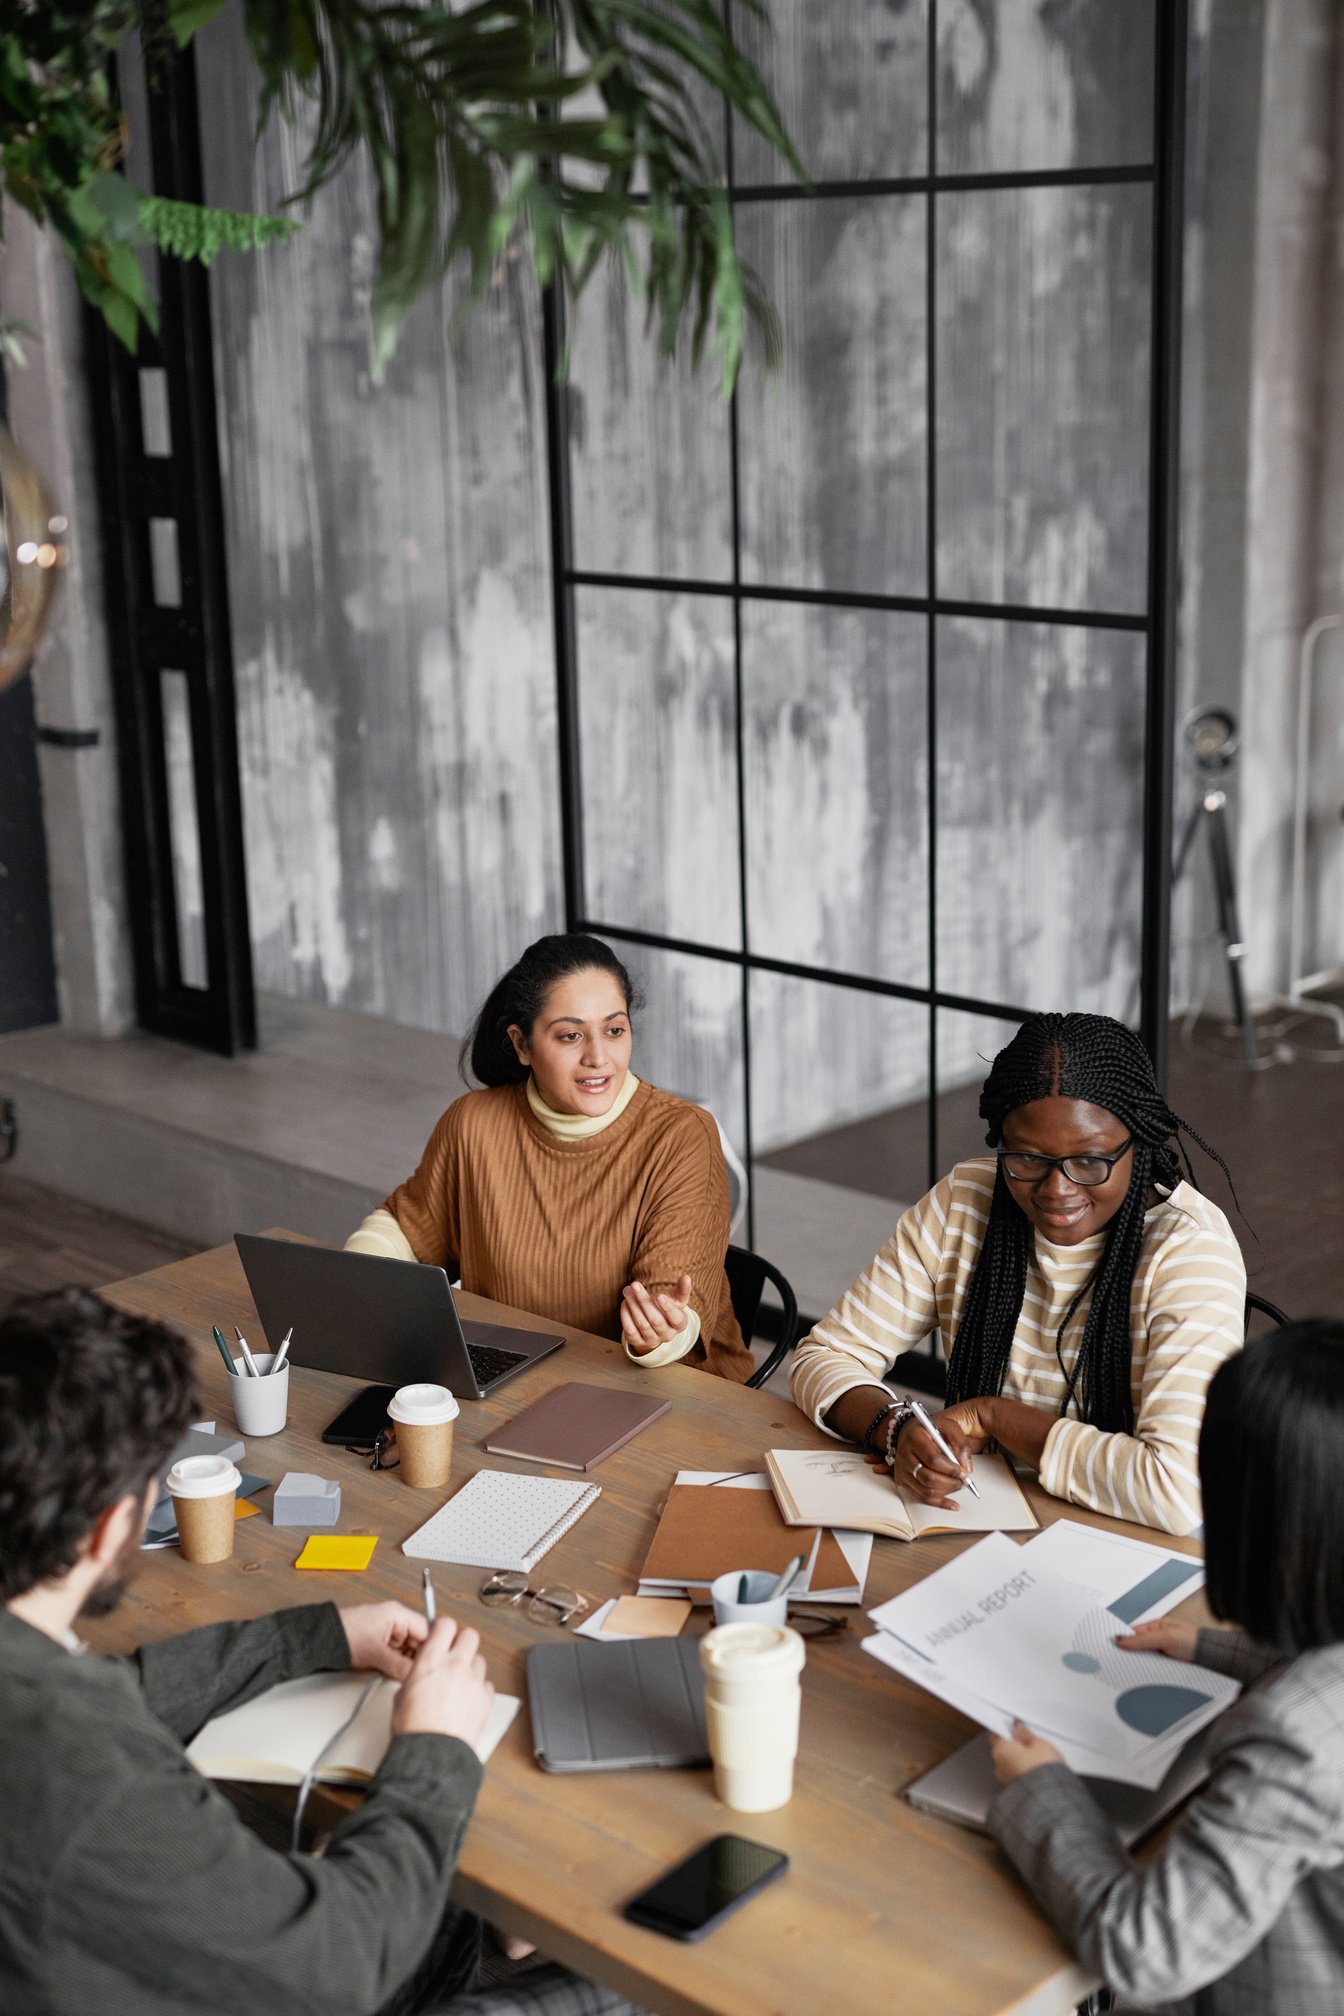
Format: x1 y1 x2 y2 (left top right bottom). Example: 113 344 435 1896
989 1322 1344 2016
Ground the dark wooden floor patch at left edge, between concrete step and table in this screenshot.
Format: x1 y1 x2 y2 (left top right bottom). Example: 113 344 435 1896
0 1169 189 1314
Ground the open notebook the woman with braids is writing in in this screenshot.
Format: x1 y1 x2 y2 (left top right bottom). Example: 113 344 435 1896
766 1450 1038 1540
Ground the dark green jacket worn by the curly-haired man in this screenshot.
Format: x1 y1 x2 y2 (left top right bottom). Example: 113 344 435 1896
0 1605 482 2016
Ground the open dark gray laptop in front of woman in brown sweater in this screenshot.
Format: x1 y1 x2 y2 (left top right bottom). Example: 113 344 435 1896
234 1232 564 1399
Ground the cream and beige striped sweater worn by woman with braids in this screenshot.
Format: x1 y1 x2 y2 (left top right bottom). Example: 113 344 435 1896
792 1157 1245 1532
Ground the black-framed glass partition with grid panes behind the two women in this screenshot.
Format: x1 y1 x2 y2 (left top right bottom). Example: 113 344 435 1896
548 0 1185 1306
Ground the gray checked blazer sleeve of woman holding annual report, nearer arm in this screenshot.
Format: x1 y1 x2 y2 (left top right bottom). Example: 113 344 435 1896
989 1693 1342 2002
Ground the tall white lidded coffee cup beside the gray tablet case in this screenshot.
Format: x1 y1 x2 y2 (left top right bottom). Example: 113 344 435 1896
699 1623 806 1812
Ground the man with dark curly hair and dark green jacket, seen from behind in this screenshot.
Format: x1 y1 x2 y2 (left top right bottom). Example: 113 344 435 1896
0 1290 627 2016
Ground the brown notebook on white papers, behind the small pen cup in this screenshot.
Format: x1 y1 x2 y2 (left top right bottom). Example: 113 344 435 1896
641 1484 854 1593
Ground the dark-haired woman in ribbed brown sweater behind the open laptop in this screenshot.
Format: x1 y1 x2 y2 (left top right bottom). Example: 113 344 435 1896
347 933 754 1383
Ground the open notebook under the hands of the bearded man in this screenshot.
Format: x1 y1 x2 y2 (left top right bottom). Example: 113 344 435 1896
187 1673 520 1784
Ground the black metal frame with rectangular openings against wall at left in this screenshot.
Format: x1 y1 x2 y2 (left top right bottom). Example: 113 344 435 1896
87 50 256 1054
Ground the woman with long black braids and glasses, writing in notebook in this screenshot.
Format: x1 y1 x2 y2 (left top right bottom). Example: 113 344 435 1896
792 1014 1245 1532
